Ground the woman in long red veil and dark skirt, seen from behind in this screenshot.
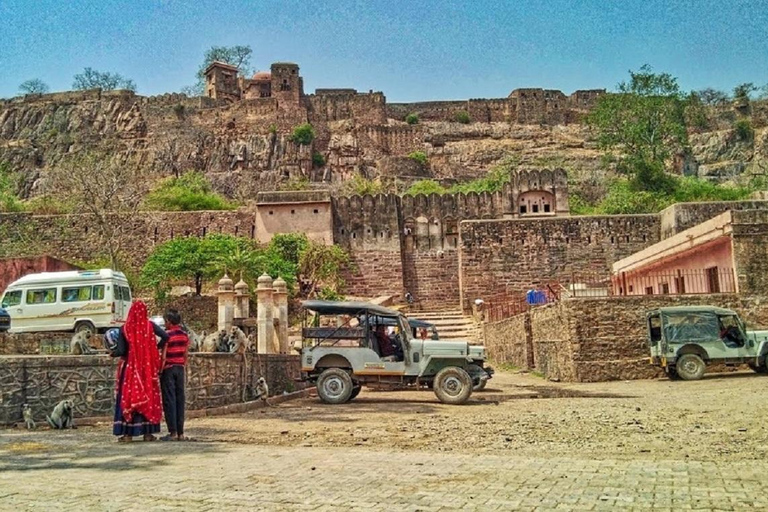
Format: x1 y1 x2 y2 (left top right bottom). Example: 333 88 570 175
112 301 167 442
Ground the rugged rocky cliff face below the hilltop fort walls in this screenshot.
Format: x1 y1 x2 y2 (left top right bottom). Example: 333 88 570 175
0 90 768 199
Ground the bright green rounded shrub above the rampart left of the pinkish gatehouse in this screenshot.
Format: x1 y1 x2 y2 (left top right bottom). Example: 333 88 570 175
144 172 235 211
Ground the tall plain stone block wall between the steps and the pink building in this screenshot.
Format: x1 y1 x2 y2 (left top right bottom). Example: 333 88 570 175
459 215 659 309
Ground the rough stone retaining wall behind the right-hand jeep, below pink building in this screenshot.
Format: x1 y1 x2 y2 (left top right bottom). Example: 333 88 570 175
483 294 768 382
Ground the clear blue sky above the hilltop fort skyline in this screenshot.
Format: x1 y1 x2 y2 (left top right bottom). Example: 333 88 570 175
0 0 768 102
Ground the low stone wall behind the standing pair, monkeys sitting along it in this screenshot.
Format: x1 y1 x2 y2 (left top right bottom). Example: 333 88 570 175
0 353 305 425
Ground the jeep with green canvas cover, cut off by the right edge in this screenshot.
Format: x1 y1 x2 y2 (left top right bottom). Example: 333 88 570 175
647 306 768 380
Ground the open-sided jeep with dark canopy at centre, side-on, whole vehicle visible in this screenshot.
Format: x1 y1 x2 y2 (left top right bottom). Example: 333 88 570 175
301 300 493 404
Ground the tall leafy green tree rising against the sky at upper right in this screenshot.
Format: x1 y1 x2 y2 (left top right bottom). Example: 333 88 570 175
587 65 688 190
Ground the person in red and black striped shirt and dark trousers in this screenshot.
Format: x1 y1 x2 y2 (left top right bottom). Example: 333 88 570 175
160 309 189 441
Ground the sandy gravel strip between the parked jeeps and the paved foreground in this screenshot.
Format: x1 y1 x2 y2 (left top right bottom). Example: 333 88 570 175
183 372 768 461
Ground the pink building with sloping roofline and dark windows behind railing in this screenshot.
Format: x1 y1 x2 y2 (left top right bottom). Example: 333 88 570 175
612 211 739 295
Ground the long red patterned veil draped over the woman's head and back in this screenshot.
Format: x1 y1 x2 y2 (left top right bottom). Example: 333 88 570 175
120 301 163 423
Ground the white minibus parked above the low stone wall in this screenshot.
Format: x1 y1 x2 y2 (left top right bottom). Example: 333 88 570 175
2 269 131 334
